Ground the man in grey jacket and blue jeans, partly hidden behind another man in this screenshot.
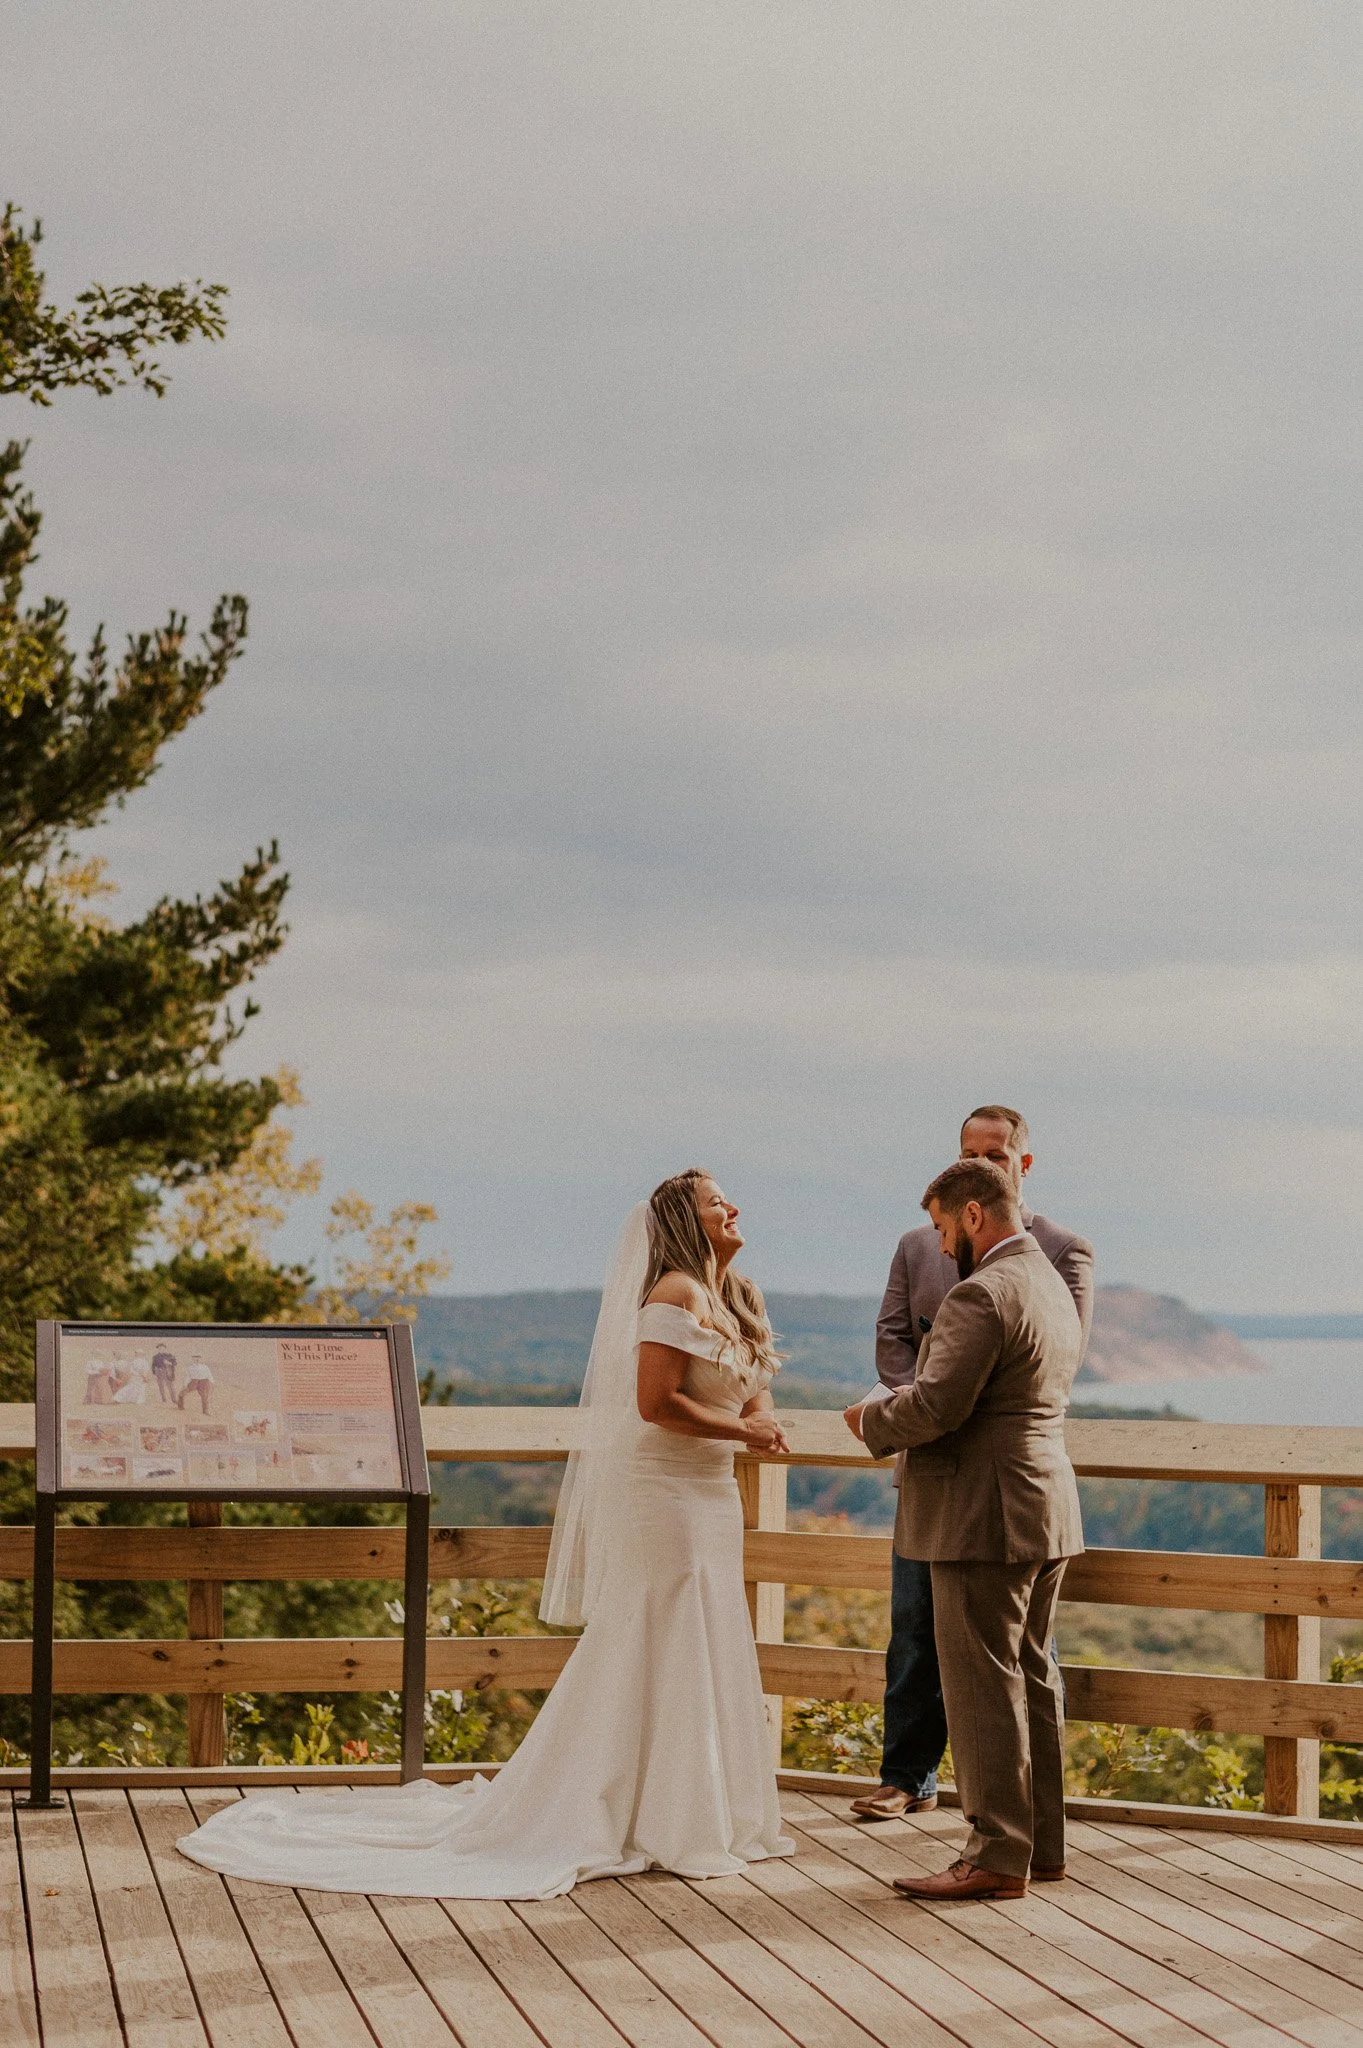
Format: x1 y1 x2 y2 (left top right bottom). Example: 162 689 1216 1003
851 1102 1093 1821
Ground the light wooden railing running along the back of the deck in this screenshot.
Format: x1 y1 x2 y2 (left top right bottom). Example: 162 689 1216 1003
0 1407 1363 1833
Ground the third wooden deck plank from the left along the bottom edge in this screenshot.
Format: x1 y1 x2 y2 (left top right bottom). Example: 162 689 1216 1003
72 1792 209 2048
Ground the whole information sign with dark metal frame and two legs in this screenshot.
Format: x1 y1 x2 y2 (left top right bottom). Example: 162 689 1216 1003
29 1323 430 1806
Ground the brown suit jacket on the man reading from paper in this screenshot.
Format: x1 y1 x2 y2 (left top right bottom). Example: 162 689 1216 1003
862 1235 1085 1565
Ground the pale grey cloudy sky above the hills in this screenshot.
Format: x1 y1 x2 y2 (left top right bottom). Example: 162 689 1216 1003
0 0 1363 1311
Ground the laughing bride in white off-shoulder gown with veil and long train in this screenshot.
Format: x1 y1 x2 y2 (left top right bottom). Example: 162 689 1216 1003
180 1167 794 1898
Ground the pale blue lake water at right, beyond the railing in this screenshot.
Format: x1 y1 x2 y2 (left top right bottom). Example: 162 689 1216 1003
1074 1337 1363 1430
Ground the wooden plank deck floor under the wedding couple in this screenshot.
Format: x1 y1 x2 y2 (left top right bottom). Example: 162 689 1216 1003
0 1788 1363 2048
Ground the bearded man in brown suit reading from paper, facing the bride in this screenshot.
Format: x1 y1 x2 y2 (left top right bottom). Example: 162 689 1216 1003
847 1159 1085 1901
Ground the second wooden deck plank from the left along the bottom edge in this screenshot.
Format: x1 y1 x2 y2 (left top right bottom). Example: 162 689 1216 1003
16 1806 125 2048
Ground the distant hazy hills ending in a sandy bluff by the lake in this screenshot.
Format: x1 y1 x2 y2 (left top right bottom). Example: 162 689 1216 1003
417 1286 1265 1391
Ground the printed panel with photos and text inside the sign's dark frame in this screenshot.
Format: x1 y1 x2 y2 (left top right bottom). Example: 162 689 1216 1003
59 1327 403 1493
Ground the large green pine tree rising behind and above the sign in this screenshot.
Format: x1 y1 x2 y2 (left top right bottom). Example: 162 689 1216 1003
0 430 305 1401
